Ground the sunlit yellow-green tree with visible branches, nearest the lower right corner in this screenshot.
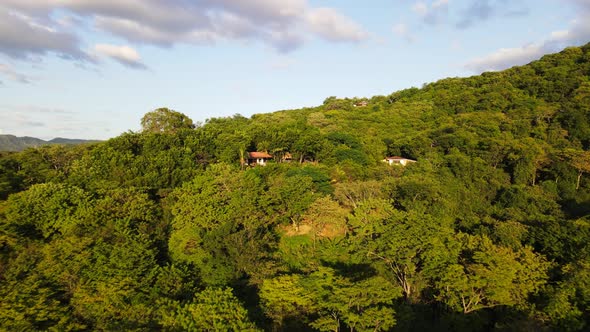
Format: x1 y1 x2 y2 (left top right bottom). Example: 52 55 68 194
437 235 549 314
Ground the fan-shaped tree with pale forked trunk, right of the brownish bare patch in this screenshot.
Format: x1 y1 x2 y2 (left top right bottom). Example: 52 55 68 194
351 208 456 302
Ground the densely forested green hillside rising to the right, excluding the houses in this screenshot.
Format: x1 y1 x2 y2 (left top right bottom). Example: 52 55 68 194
0 45 590 331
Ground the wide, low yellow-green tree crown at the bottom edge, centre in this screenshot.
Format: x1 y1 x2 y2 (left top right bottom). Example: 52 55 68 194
260 267 400 331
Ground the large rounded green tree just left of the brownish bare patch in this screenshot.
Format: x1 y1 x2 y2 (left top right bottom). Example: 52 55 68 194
169 165 276 285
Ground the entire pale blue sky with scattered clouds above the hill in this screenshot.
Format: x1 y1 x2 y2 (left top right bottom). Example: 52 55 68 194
0 0 590 139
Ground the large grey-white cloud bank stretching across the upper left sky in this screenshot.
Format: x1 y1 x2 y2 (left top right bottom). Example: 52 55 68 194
0 0 368 61
